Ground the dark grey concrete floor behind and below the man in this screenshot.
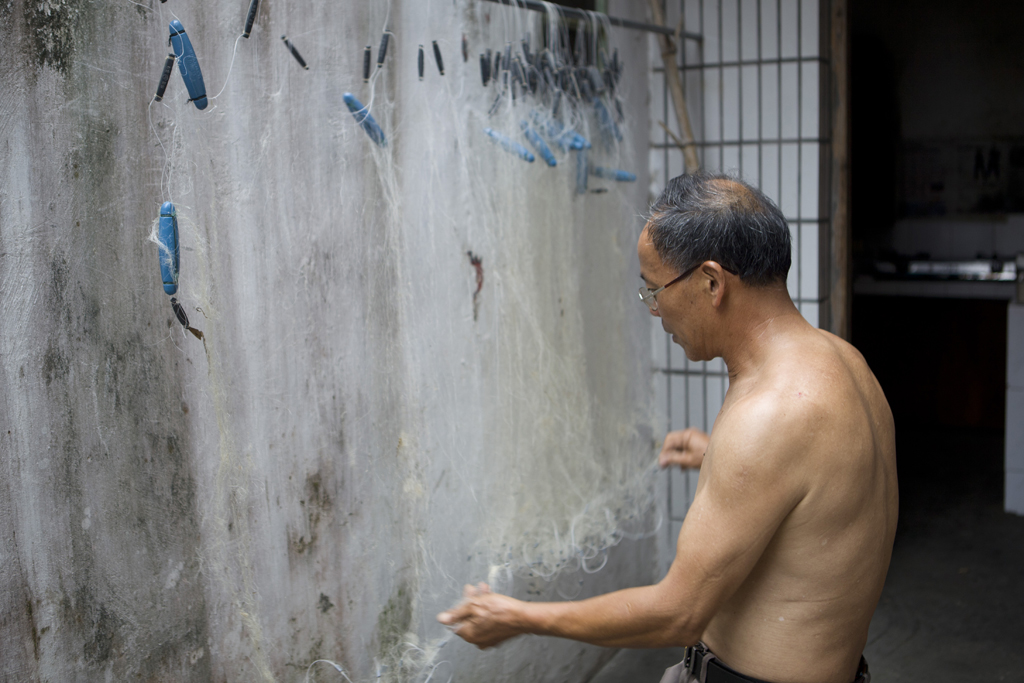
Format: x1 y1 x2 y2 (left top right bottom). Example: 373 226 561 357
591 429 1024 683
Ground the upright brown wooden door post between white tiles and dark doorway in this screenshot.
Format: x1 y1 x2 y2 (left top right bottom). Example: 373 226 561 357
828 0 853 341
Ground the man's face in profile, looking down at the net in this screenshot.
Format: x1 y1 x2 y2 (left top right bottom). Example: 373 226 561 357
637 227 700 360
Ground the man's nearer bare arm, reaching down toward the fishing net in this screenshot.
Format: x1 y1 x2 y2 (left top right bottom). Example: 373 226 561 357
438 404 806 647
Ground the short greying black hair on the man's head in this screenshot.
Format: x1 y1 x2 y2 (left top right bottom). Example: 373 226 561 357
647 173 793 287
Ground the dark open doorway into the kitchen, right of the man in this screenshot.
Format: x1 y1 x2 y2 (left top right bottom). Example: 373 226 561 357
850 0 1024 683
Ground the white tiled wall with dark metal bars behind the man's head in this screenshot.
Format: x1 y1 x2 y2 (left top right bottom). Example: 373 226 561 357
650 0 828 565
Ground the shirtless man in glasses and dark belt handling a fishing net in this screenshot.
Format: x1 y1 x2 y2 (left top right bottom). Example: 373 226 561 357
438 174 898 683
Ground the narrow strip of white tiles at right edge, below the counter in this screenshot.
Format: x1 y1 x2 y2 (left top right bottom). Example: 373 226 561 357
1006 303 1024 515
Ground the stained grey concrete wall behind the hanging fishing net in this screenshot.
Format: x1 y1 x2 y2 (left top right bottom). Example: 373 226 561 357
0 0 655 681
